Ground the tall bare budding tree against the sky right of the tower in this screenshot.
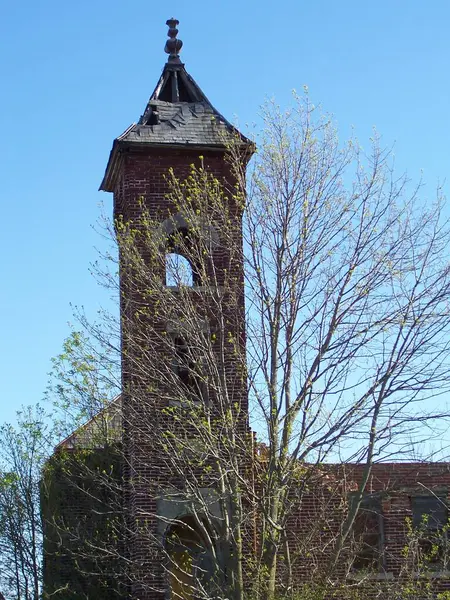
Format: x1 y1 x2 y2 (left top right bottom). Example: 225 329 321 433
234 97 450 595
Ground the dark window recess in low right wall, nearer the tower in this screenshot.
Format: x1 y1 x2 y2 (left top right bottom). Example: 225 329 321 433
350 494 384 571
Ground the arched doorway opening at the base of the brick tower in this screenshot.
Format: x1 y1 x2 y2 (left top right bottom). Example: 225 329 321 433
165 516 215 600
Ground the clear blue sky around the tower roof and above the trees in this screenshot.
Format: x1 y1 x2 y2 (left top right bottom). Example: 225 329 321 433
0 0 450 422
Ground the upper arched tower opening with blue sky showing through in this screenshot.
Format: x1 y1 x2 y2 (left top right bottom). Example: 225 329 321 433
166 227 200 287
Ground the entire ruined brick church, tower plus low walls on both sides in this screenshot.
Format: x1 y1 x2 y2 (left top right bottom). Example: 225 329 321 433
41 19 450 600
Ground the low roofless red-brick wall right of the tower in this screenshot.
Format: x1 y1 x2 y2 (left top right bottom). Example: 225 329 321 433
280 462 450 598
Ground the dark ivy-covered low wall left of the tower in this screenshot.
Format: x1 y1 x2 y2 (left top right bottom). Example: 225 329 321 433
41 445 126 600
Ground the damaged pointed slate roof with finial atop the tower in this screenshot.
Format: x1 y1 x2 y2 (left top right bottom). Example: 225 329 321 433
100 19 253 192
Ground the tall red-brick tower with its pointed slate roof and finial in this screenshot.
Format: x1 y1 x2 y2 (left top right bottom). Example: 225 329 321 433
100 19 253 600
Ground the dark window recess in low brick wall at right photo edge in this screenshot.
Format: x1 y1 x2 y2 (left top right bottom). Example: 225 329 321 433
411 496 449 570
